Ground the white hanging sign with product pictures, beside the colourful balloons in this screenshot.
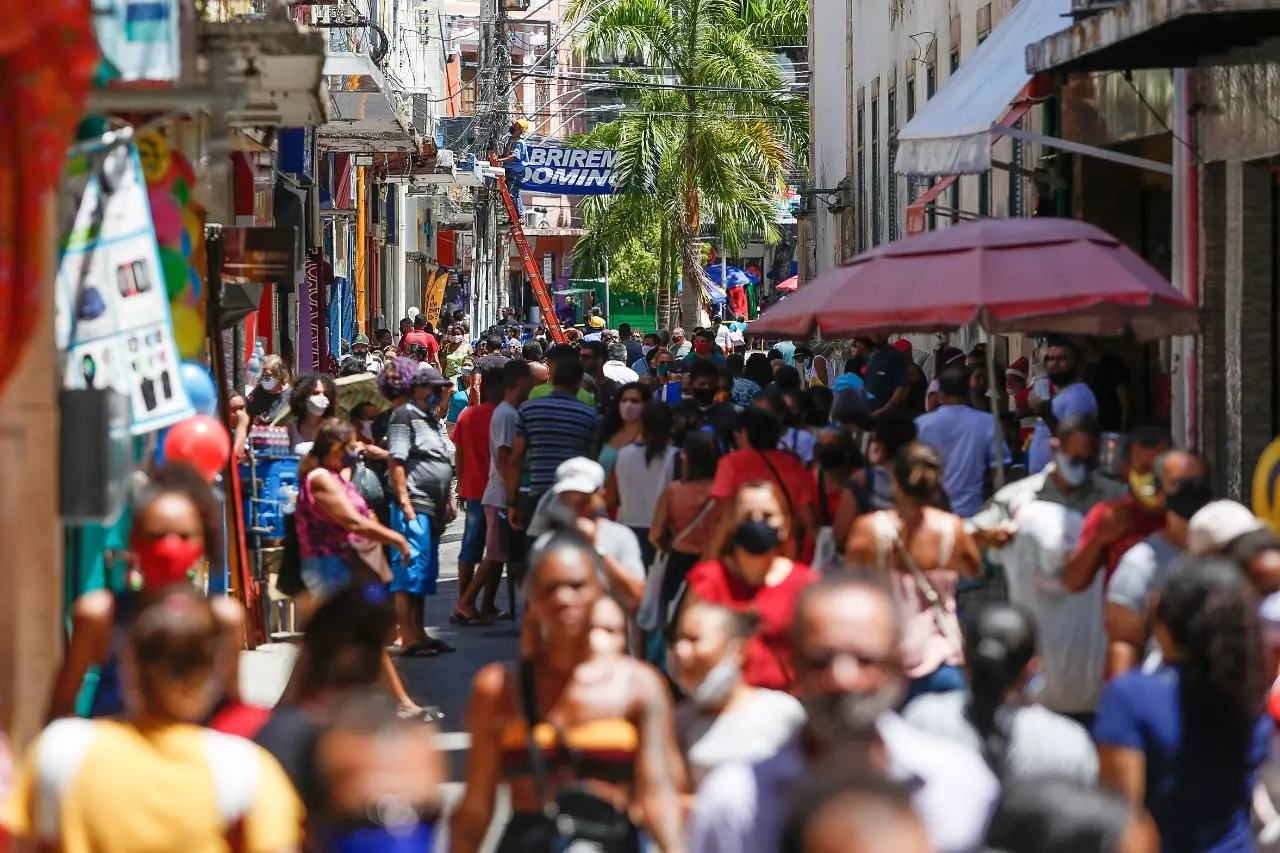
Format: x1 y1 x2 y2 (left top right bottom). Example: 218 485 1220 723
55 145 196 435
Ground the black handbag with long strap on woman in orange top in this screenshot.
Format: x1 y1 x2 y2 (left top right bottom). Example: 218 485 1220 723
520 660 639 853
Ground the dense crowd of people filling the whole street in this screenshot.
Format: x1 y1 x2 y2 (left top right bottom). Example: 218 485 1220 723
4 307 1280 853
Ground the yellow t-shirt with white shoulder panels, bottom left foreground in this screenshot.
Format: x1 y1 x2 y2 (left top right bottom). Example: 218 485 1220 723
4 719 302 853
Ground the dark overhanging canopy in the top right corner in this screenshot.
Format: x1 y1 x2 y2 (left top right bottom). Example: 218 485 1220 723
1027 0 1280 72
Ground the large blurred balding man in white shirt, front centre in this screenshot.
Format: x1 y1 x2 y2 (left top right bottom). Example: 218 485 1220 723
689 574 1000 853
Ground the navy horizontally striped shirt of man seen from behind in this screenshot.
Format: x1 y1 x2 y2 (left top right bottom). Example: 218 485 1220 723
516 391 600 494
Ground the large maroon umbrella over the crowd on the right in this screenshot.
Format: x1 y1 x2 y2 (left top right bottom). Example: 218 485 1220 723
751 218 1199 341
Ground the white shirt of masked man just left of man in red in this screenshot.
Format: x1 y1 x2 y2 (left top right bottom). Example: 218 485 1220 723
993 501 1107 713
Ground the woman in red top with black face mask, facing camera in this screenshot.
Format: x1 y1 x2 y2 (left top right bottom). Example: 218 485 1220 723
686 480 818 690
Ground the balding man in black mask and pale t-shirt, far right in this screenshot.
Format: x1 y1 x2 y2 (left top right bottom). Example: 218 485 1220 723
1107 451 1213 678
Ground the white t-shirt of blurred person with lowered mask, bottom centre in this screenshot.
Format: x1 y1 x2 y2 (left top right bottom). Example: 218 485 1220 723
676 689 805 788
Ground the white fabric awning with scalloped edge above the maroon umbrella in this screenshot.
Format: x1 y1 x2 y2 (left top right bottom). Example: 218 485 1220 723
893 0 1071 175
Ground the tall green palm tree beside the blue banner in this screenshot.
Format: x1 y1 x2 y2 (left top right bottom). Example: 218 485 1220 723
570 0 808 324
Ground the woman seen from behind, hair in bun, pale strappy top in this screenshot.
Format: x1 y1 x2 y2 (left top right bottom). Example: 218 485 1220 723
845 442 982 699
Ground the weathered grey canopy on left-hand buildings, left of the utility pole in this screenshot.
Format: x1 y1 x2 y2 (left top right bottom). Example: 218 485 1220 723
316 51 419 154
